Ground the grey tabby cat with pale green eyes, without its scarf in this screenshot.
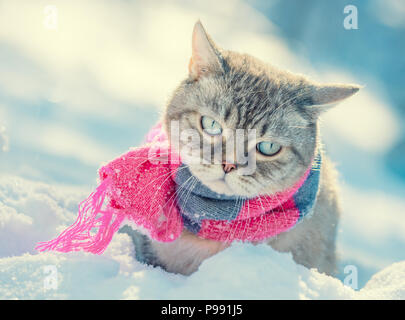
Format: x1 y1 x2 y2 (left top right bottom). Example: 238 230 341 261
121 21 360 275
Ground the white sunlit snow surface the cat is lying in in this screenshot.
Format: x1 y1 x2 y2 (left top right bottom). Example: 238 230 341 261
0 177 405 299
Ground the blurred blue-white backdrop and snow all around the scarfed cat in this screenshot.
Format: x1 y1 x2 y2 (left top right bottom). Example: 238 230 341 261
0 0 405 299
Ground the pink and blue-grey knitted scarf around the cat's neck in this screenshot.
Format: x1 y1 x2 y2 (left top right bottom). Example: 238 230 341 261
36 124 321 254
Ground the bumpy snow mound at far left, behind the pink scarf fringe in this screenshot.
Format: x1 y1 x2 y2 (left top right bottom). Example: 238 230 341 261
0 177 84 257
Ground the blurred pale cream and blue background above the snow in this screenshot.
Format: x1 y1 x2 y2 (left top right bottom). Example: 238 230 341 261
0 0 405 290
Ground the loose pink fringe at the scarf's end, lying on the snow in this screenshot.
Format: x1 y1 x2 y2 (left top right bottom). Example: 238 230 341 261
35 178 125 254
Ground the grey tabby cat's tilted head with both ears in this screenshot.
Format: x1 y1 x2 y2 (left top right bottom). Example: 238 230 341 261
164 21 360 197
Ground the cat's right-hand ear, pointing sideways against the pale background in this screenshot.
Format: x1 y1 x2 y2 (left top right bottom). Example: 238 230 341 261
307 84 362 116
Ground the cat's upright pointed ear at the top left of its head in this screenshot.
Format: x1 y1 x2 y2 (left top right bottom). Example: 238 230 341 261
188 21 222 80
